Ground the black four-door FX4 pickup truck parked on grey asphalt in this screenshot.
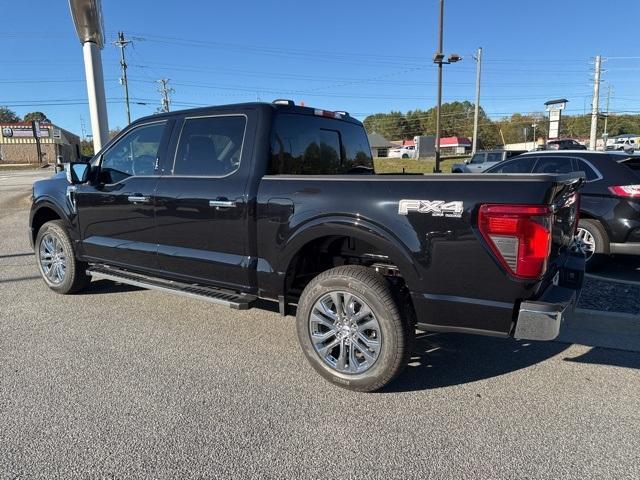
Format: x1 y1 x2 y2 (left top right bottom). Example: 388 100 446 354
30 101 584 391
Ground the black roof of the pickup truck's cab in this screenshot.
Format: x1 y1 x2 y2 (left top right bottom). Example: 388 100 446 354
132 102 362 125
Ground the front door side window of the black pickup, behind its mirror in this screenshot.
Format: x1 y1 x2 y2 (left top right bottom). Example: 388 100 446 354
100 122 165 184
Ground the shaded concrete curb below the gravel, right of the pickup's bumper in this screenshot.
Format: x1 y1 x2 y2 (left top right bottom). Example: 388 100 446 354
556 308 640 352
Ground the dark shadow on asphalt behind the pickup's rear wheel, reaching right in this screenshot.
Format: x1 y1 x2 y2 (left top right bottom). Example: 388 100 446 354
383 333 640 393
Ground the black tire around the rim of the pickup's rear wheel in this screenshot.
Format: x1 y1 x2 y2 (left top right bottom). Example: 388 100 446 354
296 265 415 392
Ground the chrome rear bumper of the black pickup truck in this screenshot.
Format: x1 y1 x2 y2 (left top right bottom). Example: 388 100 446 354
513 254 584 340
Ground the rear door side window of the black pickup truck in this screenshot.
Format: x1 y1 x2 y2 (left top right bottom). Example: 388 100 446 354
173 115 247 177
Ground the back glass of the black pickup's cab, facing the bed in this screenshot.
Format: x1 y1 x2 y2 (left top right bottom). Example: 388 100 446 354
269 114 373 175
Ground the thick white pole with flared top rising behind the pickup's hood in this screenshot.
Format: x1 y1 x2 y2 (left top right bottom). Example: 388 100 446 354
69 0 109 153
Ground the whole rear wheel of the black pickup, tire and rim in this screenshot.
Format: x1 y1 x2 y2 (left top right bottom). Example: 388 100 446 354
296 265 415 392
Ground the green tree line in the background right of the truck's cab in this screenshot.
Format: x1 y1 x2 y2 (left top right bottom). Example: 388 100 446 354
364 101 640 148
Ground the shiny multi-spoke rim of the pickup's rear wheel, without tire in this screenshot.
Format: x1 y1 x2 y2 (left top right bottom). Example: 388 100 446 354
309 291 382 374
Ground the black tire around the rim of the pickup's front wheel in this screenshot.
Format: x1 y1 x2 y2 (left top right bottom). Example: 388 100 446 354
35 220 91 294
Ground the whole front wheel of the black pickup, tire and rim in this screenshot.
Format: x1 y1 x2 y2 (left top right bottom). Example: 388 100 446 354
35 220 90 294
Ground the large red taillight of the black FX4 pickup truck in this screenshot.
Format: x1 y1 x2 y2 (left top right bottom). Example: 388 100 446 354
478 205 553 279
